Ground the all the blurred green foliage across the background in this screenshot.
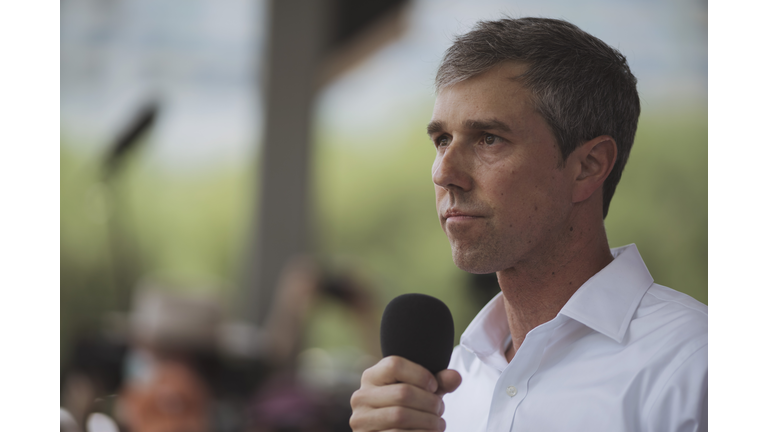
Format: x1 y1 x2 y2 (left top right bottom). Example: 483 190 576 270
61 103 707 356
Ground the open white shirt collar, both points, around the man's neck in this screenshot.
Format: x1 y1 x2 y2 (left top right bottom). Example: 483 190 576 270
460 244 653 364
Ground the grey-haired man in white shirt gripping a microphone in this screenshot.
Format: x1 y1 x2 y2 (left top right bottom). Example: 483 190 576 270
350 18 707 432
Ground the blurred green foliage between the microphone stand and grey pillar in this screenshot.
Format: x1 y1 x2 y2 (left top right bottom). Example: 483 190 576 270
118 160 254 296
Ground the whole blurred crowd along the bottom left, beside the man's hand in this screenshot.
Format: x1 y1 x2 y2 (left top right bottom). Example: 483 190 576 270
61 258 380 432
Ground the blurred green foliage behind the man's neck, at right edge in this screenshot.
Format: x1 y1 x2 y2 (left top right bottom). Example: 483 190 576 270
605 109 708 303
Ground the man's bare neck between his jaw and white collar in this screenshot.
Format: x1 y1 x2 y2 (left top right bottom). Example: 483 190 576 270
496 226 613 361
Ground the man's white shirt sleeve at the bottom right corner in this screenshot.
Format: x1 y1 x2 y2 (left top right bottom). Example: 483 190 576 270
644 345 708 432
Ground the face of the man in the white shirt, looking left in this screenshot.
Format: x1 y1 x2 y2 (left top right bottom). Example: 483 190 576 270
428 63 572 273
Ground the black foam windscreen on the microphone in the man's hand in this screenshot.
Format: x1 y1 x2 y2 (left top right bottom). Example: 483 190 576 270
381 294 453 374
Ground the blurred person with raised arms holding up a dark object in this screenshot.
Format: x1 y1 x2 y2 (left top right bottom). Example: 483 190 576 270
247 257 381 432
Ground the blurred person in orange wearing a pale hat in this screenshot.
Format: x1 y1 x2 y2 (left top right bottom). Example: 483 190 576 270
115 289 221 432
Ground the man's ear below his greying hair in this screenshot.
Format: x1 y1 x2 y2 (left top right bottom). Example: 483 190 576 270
568 135 617 205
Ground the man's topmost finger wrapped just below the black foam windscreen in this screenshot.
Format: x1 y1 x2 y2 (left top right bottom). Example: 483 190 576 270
361 356 437 393
